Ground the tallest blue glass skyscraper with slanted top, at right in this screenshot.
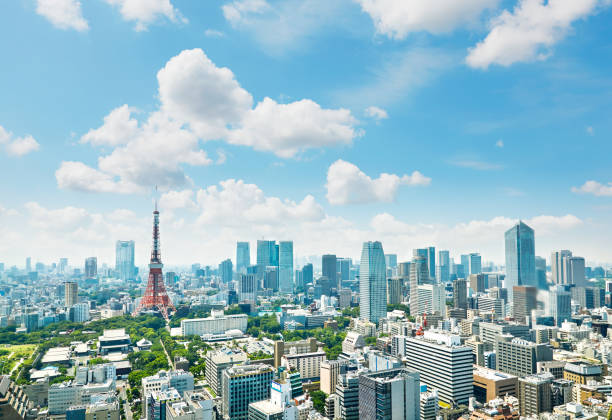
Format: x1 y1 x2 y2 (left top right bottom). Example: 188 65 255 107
505 221 536 300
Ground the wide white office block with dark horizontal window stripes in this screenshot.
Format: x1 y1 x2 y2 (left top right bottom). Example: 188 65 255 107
405 330 474 405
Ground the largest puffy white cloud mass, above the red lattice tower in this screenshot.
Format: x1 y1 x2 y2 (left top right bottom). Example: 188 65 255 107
55 49 361 194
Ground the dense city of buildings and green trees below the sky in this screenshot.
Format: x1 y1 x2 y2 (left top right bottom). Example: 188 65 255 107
0 202 612 420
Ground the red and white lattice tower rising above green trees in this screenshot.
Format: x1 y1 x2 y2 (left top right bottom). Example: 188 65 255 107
137 203 175 320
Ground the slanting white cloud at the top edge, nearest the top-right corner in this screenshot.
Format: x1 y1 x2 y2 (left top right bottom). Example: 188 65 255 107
466 0 609 69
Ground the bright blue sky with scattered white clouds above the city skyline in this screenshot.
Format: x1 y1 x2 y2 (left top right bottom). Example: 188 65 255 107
0 0 612 265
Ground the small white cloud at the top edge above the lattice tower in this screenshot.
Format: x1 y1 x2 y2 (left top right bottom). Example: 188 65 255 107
106 0 187 31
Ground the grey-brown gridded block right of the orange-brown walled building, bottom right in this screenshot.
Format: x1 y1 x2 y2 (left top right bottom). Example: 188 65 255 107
518 373 554 417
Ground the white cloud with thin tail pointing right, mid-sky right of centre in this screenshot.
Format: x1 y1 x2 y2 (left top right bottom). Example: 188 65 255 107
326 159 431 205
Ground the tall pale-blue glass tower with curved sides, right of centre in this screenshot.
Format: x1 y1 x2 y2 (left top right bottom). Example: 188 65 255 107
358 242 387 325
